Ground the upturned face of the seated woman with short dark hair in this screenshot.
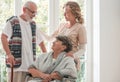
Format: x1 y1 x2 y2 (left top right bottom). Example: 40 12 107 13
52 40 66 51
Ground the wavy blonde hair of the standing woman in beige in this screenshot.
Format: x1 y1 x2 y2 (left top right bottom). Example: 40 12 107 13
63 1 84 24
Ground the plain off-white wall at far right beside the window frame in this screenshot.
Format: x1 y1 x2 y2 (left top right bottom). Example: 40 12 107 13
100 0 120 82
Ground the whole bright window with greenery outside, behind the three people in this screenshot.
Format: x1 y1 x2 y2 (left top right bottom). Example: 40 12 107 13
0 0 89 82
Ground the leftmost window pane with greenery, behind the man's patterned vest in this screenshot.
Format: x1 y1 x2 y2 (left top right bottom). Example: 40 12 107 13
0 0 14 82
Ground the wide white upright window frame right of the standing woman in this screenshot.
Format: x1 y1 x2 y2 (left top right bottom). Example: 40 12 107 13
85 0 100 82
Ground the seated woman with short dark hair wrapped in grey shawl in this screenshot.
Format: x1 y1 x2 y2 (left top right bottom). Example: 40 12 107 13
28 36 77 82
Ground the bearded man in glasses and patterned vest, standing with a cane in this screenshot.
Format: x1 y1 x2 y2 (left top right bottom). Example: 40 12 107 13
1 1 46 82
